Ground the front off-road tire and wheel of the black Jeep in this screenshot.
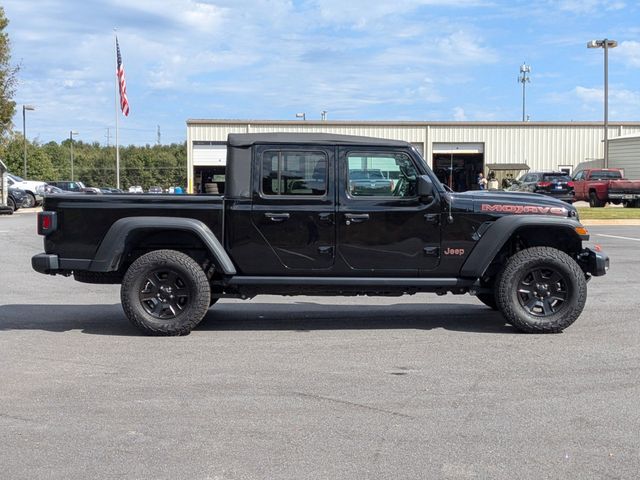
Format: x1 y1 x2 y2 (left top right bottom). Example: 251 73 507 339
496 247 587 333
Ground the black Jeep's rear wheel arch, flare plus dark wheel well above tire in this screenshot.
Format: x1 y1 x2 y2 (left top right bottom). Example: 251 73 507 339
89 217 236 275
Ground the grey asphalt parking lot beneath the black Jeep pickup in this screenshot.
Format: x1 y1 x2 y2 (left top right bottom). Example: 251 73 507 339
0 211 640 480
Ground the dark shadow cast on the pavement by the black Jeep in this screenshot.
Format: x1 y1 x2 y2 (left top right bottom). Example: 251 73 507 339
0 301 517 336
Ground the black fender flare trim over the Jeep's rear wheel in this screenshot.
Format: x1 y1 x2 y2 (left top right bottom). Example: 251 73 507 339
89 217 236 275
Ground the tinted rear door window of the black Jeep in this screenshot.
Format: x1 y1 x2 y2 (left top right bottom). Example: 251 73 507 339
262 150 328 196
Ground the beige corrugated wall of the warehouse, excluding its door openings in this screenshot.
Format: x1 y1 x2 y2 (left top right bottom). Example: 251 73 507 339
187 119 640 191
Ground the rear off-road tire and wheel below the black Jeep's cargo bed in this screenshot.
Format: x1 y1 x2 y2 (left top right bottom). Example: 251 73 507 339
120 250 211 336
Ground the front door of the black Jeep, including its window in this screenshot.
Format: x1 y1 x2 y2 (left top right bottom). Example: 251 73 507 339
336 147 440 276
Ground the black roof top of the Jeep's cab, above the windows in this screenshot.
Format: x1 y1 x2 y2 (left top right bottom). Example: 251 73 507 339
227 133 410 147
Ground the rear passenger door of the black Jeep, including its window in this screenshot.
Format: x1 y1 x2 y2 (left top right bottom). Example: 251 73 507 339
251 145 336 275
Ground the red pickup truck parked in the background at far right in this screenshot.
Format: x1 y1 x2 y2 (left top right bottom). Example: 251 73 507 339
573 168 640 207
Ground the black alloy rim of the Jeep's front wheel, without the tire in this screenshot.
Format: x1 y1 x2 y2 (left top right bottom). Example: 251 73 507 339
518 266 570 317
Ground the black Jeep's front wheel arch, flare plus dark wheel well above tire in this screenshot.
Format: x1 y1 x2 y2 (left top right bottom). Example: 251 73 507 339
460 215 589 278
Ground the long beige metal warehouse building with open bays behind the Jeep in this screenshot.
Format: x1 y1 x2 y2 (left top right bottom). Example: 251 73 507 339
187 120 640 193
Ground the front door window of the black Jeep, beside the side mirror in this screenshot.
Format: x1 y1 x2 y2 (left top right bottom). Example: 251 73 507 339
347 152 418 197
